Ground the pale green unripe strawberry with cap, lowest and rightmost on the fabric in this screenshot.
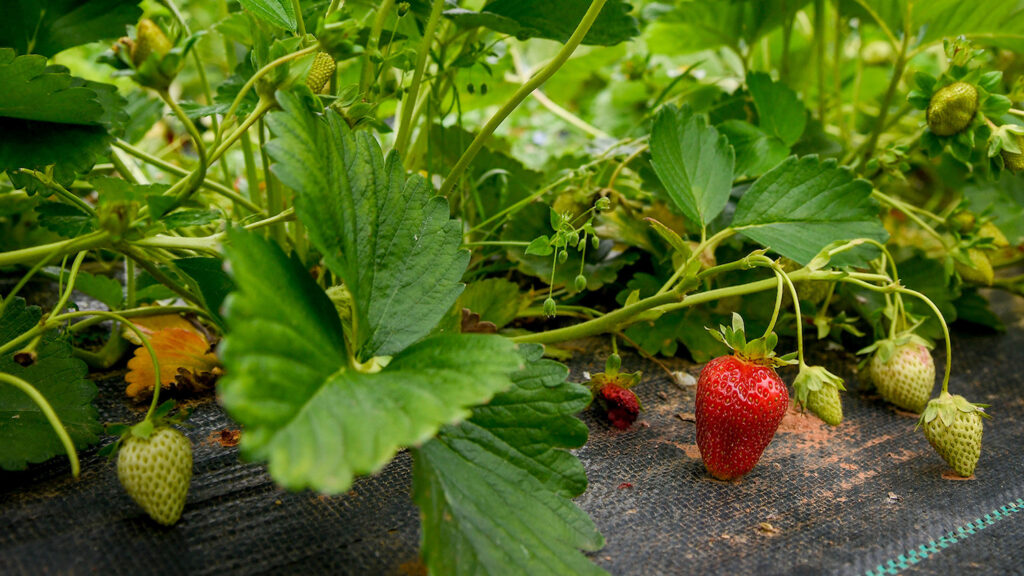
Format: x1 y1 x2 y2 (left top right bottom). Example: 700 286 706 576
918 392 989 478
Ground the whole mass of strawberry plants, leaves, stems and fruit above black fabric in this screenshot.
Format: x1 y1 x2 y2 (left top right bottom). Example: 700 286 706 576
0 0 1024 574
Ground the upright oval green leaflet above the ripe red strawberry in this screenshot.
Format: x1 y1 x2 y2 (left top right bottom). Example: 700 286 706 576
650 107 735 225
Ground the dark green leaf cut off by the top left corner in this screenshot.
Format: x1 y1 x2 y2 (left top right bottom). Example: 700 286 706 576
0 0 142 56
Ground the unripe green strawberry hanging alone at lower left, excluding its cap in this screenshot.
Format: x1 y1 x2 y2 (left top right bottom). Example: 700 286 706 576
118 426 193 526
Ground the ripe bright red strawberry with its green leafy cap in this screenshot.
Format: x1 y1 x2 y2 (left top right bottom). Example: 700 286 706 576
694 314 792 480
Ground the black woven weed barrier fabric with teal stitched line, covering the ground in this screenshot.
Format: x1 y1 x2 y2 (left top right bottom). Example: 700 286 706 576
0 295 1024 575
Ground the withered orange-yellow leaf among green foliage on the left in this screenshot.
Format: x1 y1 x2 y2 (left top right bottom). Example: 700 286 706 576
125 326 220 398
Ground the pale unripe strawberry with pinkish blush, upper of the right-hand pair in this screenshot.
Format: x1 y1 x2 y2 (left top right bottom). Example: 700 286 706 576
869 340 935 413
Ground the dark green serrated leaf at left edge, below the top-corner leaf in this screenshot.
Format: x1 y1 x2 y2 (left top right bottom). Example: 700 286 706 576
0 48 127 192
